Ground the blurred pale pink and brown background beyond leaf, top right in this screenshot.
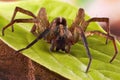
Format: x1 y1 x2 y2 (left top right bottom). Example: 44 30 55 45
0 0 120 38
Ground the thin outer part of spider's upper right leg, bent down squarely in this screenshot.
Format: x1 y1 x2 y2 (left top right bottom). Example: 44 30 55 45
85 17 110 44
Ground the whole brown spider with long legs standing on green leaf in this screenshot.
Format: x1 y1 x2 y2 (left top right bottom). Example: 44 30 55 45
2 7 118 72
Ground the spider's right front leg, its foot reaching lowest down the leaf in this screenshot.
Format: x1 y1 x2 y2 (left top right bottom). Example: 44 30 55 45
70 23 92 72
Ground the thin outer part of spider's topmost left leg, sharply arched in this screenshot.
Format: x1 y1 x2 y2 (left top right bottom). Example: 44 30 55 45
11 7 36 32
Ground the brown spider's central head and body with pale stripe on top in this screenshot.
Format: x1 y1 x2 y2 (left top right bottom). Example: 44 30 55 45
45 17 73 52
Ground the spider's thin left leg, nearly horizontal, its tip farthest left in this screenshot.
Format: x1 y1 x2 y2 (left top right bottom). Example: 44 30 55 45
2 18 37 36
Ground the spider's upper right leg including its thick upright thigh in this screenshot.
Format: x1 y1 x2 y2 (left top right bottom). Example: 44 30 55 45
73 8 110 44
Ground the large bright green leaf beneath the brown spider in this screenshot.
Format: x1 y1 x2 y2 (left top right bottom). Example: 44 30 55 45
0 0 120 80
